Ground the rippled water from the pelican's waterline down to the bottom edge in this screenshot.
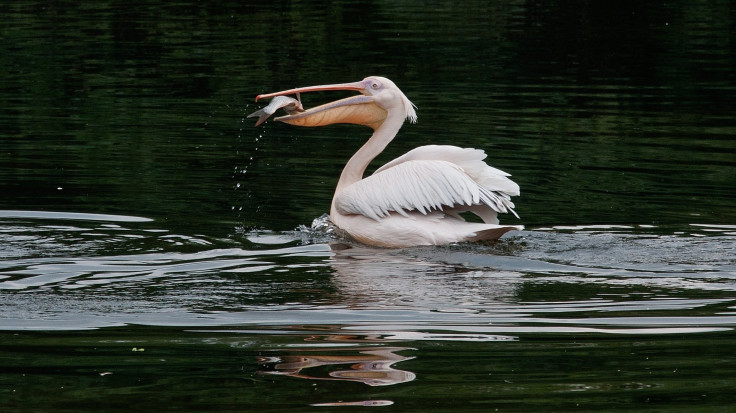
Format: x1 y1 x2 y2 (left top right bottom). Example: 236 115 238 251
0 211 736 411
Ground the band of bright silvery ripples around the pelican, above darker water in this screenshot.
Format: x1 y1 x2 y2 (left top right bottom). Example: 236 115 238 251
0 212 736 334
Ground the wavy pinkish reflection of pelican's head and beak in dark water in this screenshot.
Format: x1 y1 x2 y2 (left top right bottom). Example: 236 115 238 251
259 347 416 386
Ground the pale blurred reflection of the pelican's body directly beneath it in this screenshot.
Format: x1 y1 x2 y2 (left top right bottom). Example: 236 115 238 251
331 244 523 312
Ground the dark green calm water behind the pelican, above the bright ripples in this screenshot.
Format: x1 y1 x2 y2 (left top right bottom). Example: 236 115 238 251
0 1 736 232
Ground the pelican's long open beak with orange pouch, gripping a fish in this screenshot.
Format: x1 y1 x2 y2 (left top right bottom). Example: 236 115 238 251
256 81 388 129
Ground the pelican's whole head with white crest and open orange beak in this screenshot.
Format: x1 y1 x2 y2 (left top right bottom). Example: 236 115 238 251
256 76 417 129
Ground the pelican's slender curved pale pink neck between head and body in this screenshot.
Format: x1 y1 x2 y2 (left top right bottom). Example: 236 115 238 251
333 113 404 200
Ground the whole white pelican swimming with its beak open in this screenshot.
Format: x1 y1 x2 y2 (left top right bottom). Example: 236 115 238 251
256 76 523 248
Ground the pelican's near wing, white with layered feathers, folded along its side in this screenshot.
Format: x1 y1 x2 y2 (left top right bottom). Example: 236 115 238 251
335 160 513 220
